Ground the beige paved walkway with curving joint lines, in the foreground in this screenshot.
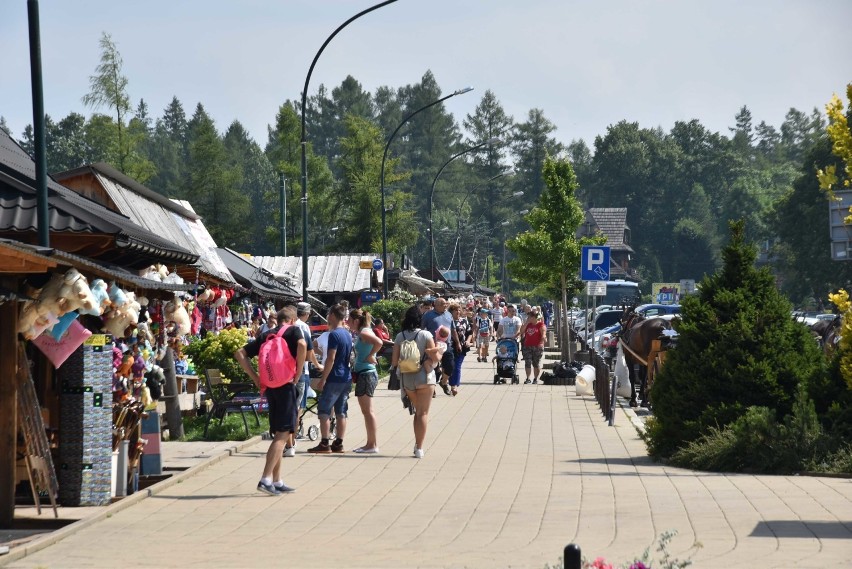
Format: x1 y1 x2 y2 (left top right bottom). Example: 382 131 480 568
0 361 852 569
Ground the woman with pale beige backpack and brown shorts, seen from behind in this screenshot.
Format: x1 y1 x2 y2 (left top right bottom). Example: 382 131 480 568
391 305 436 458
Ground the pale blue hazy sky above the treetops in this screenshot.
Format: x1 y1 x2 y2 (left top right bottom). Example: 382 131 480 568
0 0 852 150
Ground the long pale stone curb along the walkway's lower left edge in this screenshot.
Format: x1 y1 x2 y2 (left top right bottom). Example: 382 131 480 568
0 435 261 567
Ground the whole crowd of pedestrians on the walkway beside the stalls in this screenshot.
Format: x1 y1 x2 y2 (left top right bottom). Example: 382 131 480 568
234 296 552 495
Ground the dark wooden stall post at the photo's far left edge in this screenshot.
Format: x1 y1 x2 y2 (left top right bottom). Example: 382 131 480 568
0 279 19 528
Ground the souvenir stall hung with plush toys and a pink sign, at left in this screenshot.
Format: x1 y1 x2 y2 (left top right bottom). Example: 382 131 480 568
18 255 191 506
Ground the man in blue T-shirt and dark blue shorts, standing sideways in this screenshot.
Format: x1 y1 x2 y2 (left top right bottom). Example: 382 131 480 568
308 304 352 454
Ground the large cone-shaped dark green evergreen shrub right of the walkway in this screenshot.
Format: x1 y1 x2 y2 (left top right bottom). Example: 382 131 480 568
647 217 825 457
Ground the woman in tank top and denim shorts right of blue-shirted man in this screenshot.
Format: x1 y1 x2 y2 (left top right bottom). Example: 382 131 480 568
349 308 383 454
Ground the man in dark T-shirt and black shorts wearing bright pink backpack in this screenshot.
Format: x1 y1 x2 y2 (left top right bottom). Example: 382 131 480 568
234 306 307 496
